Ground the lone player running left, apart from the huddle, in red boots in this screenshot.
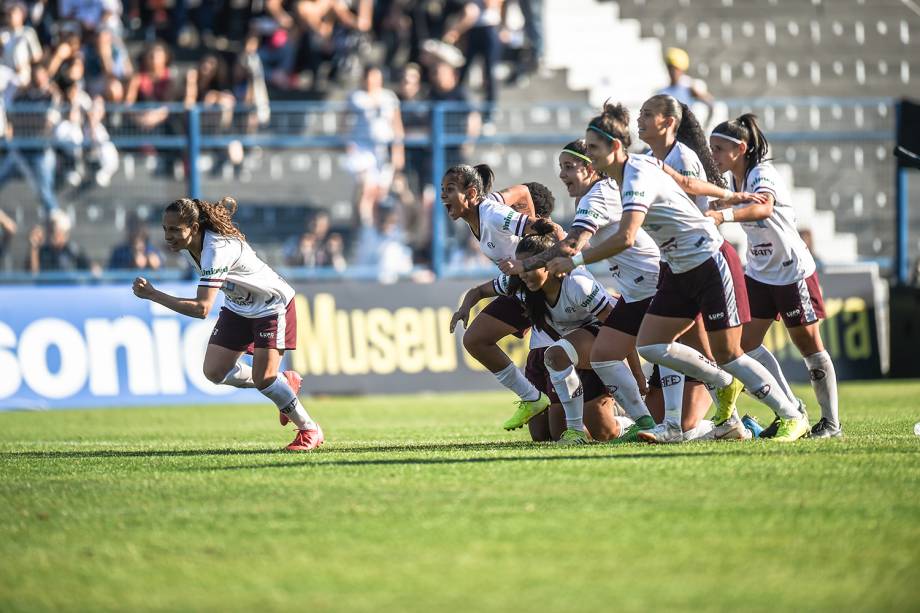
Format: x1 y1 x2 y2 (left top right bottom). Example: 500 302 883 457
133 198 324 451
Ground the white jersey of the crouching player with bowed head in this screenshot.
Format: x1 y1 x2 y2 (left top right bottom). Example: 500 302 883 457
492 266 611 338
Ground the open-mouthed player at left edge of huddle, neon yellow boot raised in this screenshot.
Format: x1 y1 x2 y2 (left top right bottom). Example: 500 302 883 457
441 164 552 430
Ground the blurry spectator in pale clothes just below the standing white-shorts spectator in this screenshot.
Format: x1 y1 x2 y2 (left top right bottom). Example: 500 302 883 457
355 207 412 283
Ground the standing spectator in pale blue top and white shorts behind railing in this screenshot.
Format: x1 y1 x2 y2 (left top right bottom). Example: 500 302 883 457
346 65 405 225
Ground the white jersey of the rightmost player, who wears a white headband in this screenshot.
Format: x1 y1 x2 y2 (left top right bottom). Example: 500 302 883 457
731 163 815 285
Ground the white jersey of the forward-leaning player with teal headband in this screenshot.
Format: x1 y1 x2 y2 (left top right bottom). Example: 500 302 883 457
621 154 724 274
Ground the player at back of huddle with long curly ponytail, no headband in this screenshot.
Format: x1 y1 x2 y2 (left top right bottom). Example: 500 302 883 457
636 94 732 442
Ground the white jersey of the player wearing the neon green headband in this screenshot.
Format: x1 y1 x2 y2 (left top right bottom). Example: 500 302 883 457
572 179 661 302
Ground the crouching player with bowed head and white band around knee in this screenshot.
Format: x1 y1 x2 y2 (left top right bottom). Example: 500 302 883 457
453 235 638 445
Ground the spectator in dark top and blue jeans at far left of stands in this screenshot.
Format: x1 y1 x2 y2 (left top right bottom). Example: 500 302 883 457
0 64 60 212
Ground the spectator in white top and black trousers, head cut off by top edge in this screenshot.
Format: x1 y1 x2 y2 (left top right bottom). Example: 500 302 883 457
443 0 503 123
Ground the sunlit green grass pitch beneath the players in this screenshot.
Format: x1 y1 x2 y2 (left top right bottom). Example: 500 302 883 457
0 382 920 611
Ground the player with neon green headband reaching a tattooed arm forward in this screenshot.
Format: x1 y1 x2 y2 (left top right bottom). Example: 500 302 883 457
500 141 661 442
